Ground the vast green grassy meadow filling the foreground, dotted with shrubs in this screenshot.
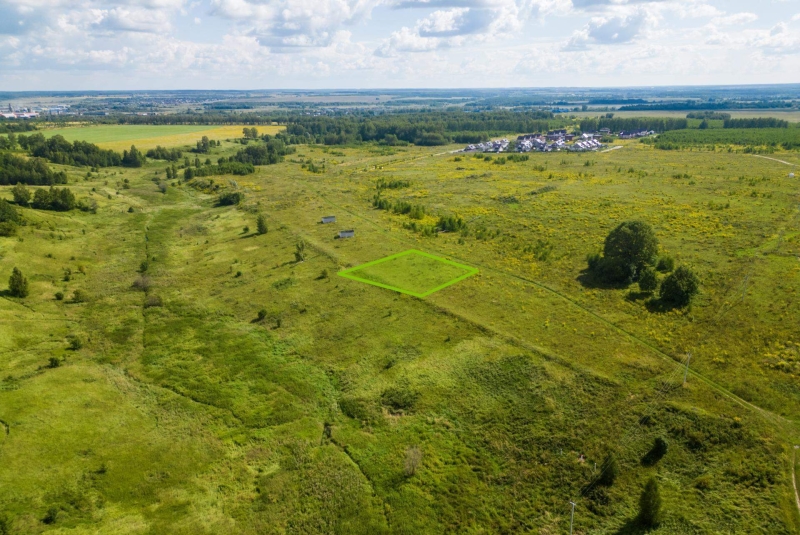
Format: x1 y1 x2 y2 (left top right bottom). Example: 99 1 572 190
0 131 800 534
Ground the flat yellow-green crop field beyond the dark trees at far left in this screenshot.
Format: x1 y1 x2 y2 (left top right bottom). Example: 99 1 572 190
42 124 283 151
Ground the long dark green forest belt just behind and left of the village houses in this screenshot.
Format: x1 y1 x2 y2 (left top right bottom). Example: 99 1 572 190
286 111 563 146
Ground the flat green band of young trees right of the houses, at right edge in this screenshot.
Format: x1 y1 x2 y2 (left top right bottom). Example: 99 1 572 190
653 128 800 150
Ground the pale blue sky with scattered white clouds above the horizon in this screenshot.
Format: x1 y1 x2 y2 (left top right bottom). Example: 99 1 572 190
0 0 800 91
